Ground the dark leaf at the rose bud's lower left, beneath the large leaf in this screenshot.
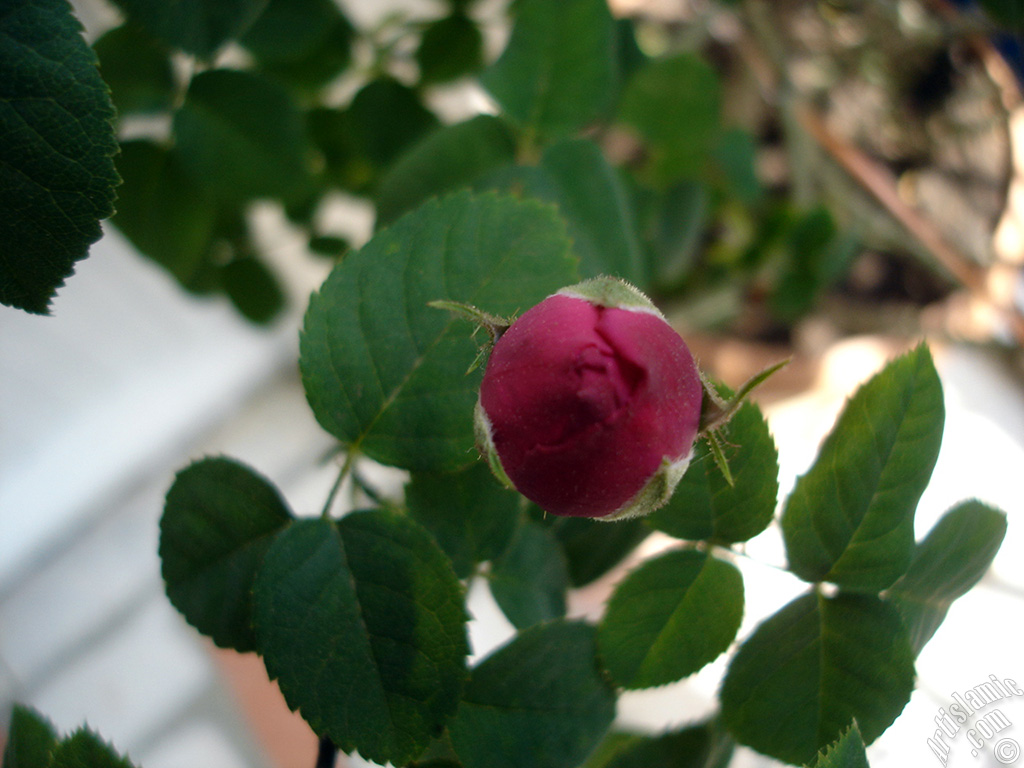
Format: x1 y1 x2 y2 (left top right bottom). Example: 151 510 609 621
406 462 520 579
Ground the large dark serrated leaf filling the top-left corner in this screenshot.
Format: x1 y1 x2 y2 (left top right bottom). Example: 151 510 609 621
0 0 120 314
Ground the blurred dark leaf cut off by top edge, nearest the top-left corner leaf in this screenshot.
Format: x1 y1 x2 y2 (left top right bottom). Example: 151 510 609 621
114 0 266 59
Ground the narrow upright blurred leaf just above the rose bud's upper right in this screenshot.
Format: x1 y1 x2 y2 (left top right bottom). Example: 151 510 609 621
644 181 711 290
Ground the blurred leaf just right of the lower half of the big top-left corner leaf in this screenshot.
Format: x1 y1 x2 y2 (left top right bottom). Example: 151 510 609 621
111 139 217 286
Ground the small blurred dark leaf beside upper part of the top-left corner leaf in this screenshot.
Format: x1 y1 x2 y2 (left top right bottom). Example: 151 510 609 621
92 24 176 117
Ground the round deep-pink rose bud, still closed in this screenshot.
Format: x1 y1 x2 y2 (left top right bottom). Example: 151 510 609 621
476 278 703 520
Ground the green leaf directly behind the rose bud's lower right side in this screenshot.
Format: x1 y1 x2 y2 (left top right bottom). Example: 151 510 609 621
645 401 778 544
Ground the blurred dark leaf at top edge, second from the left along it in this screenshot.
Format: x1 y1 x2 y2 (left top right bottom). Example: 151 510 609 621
241 0 355 86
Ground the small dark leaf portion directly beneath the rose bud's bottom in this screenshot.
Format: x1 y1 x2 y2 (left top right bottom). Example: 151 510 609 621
546 517 650 587
